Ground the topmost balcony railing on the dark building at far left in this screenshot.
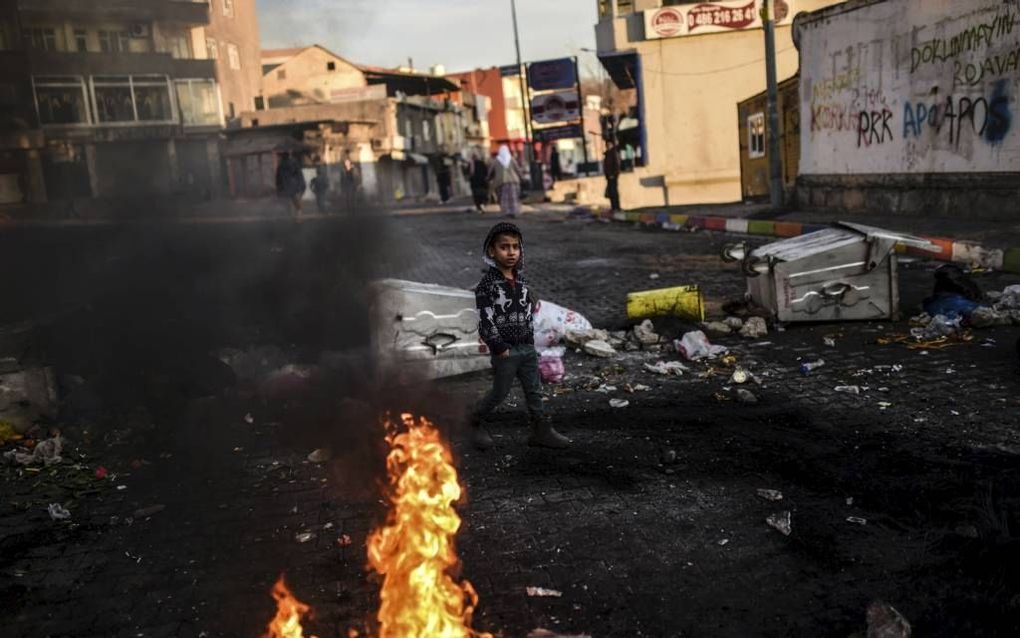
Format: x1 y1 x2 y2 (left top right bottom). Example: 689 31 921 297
17 0 209 24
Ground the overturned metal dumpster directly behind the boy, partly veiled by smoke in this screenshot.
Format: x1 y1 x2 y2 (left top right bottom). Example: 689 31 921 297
369 279 491 381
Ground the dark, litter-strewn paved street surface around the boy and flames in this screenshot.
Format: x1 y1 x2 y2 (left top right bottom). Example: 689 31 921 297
0 210 1020 638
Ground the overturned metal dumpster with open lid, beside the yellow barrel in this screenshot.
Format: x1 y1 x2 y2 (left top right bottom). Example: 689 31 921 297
744 222 941 322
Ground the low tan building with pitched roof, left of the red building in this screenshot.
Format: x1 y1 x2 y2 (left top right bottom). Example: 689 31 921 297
224 45 489 204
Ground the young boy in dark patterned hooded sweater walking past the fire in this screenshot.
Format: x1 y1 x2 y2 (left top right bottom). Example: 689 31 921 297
471 223 570 449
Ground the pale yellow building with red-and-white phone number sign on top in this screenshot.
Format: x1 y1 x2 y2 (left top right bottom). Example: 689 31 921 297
596 0 838 208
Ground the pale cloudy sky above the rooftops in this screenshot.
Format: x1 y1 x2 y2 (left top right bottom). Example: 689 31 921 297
257 0 598 75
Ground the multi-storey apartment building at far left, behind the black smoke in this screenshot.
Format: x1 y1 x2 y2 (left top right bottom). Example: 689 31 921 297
0 0 258 208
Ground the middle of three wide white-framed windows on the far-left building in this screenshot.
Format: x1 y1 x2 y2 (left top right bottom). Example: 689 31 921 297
92 76 173 124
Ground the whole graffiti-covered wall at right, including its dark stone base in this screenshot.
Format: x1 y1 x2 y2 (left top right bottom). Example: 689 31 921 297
797 0 1020 219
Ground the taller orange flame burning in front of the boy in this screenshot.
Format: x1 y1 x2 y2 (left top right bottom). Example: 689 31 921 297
368 414 491 638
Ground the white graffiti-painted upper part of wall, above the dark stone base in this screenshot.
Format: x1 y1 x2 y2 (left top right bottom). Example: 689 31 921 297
800 0 1020 175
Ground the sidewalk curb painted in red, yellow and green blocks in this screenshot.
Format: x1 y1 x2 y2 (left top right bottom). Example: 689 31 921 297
599 211 1020 273
